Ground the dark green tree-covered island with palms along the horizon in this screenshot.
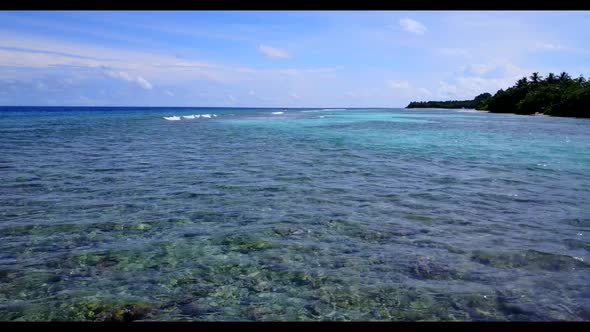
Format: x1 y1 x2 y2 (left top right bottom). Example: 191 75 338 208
406 72 590 118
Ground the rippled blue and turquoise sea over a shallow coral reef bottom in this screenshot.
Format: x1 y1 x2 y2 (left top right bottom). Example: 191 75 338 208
0 108 590 320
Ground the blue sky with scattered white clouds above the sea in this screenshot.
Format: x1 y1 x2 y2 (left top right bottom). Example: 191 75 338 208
0 11 590 107
